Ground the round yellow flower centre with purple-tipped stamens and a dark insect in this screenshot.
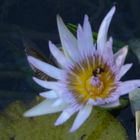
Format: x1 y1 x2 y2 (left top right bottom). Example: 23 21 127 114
67 56 116 103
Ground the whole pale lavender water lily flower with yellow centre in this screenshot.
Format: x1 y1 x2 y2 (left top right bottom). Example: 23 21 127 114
24 6 140 132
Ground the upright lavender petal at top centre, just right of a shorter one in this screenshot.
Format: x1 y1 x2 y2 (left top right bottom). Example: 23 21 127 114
83 15 95 52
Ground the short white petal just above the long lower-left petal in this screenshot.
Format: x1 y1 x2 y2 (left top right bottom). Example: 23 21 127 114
39 90 59 99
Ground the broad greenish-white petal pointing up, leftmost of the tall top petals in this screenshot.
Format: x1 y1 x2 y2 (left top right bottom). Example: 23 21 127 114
57 15 77 59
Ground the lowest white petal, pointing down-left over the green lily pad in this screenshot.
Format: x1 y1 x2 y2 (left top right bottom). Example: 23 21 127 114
70 104 92 132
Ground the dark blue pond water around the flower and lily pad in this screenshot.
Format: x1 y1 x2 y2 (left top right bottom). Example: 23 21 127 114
0 0 140 140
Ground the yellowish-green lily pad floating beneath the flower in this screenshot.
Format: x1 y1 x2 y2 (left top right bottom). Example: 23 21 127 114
0 99 127 140
